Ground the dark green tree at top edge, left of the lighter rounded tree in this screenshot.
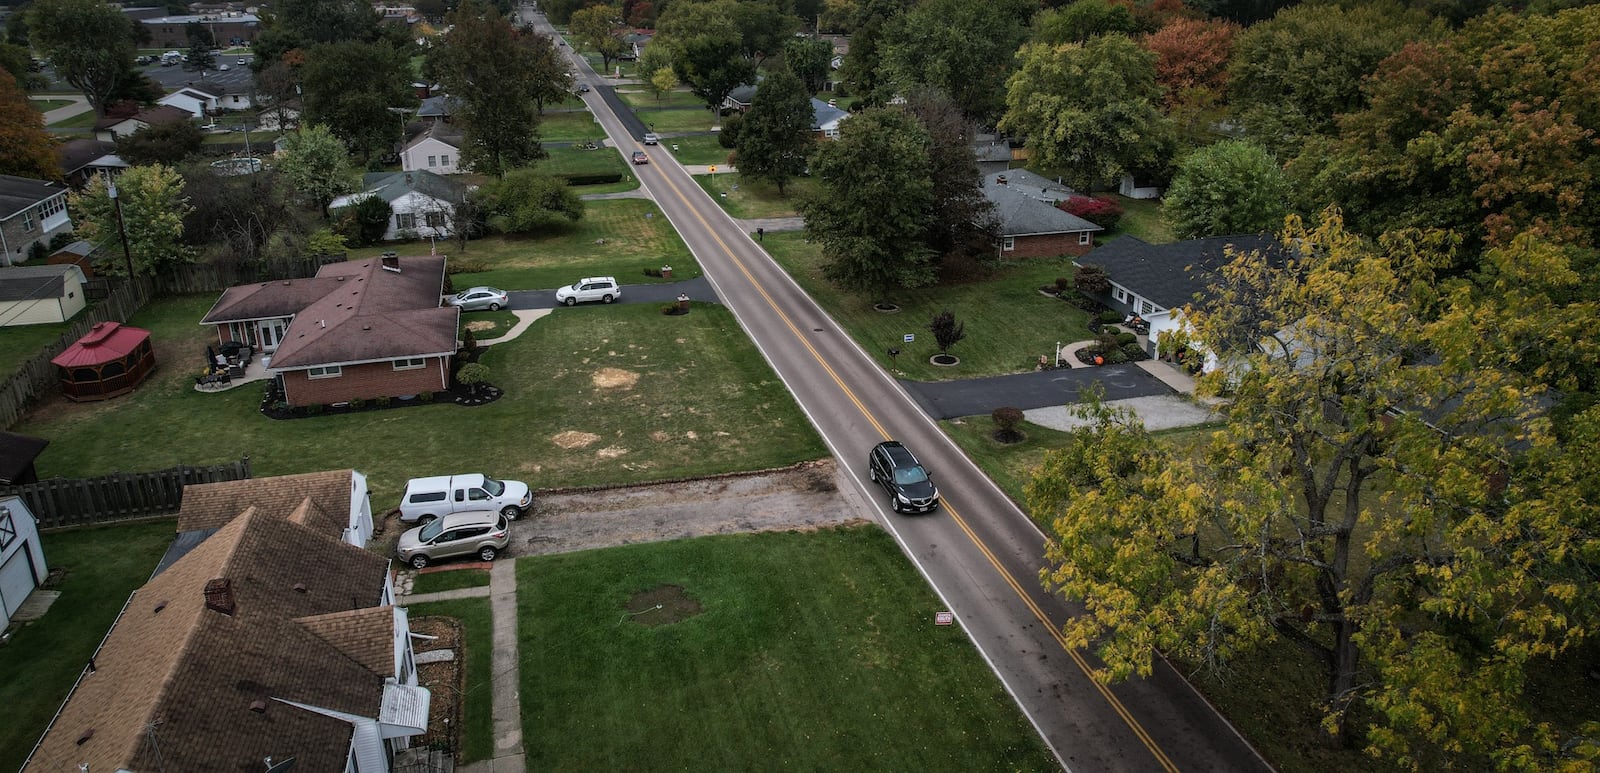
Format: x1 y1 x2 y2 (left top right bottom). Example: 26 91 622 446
883 0 1038 123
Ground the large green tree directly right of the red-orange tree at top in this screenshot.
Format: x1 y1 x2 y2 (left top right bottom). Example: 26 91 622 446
1227 3 1427 155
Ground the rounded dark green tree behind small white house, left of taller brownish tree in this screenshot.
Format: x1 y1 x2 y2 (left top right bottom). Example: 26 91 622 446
301 42 418 162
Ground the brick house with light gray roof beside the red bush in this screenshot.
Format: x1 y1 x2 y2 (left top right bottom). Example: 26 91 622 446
982 170 1104 258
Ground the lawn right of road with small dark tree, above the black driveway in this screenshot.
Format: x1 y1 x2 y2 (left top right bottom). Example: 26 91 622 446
762 232 1093 381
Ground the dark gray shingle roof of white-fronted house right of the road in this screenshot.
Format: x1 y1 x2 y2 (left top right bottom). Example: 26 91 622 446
1077 234 1283 309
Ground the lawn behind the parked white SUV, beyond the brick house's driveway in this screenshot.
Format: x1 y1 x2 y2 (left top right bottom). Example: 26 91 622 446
349 198 701 292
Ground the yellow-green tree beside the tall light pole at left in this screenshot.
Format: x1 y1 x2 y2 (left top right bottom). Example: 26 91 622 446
67 163 194 277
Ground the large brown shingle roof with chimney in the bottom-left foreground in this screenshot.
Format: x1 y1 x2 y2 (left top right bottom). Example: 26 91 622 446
29 511 392 771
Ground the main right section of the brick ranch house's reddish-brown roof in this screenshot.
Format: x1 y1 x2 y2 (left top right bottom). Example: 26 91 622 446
272 256 459 368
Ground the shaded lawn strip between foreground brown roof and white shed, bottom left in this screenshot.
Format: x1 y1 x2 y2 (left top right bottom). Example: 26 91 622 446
0 520 174 770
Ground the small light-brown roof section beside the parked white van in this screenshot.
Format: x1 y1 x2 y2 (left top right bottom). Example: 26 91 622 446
178 469 355 539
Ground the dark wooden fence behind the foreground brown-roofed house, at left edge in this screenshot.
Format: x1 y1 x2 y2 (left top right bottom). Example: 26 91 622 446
0 456 250 528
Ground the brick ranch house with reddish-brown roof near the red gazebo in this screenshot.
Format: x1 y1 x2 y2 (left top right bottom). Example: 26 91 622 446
200 254 461 405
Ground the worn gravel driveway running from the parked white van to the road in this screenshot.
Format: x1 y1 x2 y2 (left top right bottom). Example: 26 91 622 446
510 459 870 555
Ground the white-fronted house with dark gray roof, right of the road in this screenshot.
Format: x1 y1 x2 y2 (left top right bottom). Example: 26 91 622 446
1074 234 1283 363
